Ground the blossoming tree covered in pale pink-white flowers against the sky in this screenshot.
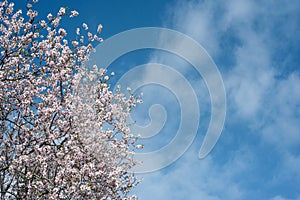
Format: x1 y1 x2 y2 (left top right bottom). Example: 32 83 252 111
0 0 140 199
